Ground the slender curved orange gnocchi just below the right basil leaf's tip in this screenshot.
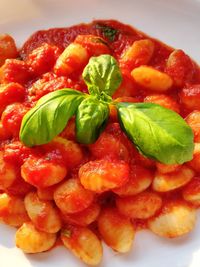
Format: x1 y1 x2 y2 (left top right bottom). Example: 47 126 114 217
152 165 195 192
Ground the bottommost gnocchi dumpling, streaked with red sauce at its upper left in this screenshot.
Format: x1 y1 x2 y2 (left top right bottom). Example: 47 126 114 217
61 226 103 266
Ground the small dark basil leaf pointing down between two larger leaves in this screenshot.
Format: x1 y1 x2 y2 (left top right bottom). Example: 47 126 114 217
76 97 109 144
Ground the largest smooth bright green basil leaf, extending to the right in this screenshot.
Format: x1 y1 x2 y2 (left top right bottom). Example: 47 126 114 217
117 103 194 164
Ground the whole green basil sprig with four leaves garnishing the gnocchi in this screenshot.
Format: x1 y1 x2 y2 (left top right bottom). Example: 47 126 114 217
20 55 194 164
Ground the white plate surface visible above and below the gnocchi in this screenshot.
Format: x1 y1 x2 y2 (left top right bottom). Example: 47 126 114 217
0 0 200 267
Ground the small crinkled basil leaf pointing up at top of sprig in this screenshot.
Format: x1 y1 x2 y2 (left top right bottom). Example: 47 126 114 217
83 55 122 96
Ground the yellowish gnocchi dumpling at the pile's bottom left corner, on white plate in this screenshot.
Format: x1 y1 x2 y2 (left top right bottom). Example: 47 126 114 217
15 222 56 253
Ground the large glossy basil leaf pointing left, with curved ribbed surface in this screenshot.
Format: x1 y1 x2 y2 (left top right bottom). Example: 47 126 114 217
20 89 84 147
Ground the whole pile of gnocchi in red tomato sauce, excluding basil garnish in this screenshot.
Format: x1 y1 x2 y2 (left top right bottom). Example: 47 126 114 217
0 20 200 266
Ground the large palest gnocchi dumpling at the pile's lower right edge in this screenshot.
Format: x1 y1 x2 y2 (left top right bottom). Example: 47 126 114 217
148 201 196 238
